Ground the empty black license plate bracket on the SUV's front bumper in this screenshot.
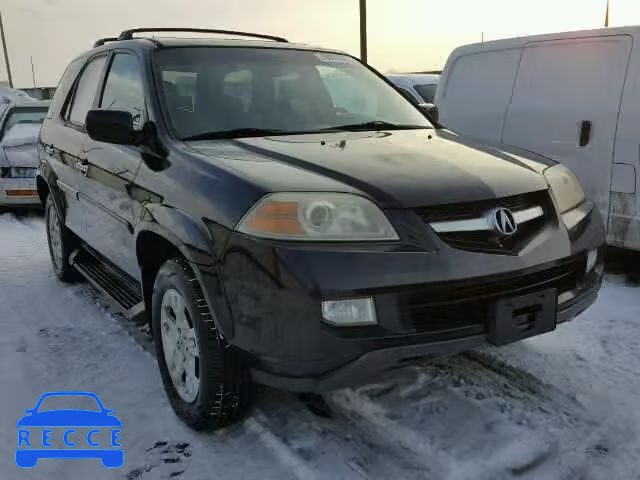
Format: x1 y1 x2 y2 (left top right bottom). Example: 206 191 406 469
487 289 558 346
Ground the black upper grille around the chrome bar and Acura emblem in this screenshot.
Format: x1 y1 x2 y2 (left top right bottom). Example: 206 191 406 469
415 190 554 255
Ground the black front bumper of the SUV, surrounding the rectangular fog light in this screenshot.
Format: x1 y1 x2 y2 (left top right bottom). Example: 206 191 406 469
215 202 604 391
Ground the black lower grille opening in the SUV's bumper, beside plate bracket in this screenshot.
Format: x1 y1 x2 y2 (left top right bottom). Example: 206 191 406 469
402 259 581 335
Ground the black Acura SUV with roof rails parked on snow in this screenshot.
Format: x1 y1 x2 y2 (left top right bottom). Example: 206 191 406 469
37 29 604 428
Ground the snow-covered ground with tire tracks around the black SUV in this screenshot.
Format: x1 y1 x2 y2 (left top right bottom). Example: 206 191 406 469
0 214 640 480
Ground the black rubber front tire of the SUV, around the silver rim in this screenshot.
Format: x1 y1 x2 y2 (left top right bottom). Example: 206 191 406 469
152 258 252 430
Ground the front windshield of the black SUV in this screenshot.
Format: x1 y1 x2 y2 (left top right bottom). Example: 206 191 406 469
155 47 431 139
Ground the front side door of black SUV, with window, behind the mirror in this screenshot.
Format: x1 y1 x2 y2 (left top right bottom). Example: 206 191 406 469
82 51 147 277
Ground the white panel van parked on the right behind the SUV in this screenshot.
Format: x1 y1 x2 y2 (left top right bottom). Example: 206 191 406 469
435 27 640 250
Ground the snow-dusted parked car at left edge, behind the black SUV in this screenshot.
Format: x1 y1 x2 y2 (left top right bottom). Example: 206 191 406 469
0 100 49 207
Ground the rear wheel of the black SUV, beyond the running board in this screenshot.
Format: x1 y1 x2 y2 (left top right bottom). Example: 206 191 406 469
44 195 80 283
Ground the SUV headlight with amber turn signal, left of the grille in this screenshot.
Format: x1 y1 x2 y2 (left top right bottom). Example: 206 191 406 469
236 192 399 242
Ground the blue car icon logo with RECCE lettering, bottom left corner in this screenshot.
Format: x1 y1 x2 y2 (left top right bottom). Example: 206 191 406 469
16 391 124 468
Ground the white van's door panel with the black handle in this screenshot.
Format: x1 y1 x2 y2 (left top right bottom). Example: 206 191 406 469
502 35 632 218
